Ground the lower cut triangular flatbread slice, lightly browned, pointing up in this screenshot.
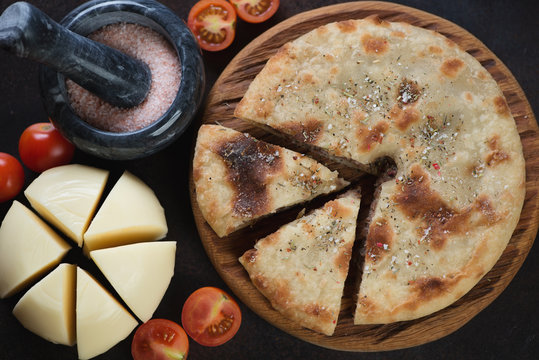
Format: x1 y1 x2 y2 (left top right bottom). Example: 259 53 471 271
239 191 360 335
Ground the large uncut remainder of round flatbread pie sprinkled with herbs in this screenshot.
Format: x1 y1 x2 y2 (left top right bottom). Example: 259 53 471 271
235 18 525 324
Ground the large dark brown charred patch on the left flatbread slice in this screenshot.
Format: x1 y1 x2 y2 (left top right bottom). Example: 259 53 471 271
215 134 284 217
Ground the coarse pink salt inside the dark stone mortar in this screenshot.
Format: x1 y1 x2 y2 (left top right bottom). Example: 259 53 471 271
66 23 181 133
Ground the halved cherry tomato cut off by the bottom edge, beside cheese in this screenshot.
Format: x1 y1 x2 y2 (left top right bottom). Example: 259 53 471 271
131 319 189 360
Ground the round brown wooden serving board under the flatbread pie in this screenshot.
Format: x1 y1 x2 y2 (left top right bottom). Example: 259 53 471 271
190 1 539 351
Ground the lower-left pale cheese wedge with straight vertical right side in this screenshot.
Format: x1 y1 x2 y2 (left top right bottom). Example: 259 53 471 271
13 264 77 346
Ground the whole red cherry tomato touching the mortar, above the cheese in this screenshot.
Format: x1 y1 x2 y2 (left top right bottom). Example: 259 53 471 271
19 123 75 172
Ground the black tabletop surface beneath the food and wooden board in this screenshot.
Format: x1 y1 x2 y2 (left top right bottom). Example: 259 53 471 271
0 0 539 360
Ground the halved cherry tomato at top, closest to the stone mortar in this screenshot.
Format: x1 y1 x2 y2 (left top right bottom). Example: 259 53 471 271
187 0 236 51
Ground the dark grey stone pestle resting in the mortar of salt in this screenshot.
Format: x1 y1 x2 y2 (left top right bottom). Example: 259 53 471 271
0 2 151 108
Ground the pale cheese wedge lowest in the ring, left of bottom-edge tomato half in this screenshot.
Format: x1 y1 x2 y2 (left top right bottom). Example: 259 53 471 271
76 268 138 359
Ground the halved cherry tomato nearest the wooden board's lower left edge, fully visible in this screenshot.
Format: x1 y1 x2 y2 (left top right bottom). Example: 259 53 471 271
182 287 241 346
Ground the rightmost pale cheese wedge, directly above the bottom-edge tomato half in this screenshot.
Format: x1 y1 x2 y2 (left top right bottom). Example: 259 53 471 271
90 241 176 322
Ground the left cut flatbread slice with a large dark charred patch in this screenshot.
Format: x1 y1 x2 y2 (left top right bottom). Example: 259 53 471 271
193 125 348 237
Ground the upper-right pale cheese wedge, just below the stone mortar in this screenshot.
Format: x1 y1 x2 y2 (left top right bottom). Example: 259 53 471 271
84 171 168 254
